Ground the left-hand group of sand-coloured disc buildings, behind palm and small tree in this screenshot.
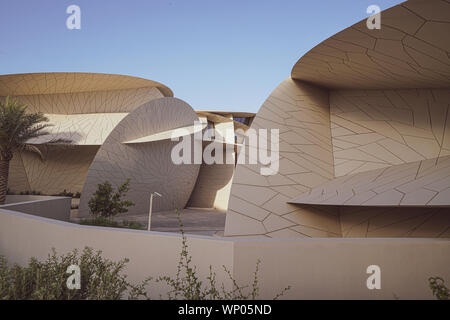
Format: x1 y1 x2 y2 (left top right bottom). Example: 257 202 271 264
0 73 254 216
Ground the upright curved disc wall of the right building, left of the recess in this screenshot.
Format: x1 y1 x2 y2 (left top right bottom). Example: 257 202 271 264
225 79 340 237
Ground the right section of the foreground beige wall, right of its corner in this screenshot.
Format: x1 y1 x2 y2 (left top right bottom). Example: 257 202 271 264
233 238 450 299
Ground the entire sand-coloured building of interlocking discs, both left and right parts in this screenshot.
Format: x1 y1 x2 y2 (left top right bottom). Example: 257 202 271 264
0 0 450 238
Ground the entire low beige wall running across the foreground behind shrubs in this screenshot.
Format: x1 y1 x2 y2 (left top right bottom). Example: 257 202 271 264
0 209 450 299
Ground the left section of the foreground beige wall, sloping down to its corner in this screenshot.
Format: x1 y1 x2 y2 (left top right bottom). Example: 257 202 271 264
0 209 233 298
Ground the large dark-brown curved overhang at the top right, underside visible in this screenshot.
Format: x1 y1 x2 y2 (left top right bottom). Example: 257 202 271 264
291 0 450 89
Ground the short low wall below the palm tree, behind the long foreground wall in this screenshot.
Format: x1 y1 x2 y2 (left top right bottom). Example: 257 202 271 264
0 195 72 221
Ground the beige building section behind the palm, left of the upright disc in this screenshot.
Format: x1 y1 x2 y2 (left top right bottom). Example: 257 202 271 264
0 73 172 194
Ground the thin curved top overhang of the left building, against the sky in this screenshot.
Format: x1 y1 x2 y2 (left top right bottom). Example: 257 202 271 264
0 72 173 97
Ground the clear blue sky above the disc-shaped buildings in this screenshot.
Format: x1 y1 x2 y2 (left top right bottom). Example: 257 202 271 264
0 0 402 112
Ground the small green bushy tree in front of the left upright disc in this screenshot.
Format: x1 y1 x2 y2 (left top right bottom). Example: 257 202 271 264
88 179 134 218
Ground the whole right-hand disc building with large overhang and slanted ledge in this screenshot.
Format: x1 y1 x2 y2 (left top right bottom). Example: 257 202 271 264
225 0 450 238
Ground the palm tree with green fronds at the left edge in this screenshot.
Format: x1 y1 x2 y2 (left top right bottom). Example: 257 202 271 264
0 97 69 204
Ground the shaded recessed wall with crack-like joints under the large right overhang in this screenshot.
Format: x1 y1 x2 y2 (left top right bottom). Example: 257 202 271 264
330 89 450 176
